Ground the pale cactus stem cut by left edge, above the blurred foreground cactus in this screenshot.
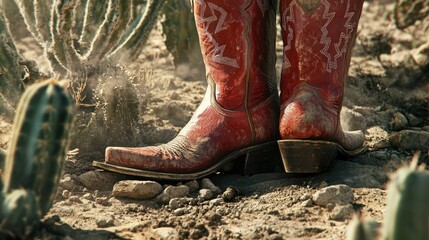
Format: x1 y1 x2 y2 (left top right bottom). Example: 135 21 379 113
0 10 24 117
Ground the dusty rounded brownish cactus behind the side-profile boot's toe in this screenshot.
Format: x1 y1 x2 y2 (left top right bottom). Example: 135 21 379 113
71 66 139 154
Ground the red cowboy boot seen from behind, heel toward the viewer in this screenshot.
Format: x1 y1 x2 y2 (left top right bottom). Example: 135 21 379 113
279 0 365 173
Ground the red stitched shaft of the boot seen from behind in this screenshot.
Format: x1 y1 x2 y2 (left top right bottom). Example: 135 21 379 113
280 0 363 108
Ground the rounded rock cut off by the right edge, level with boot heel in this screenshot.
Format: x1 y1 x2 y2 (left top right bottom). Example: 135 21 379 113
389 130 429 151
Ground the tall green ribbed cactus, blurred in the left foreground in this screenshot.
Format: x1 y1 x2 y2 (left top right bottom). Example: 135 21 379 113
0 80 73 238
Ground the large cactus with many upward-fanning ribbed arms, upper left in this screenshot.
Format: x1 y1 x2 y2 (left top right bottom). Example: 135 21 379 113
7 0 165 73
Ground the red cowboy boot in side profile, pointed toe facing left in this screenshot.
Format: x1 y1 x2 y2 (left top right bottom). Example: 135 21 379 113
94 0 278 180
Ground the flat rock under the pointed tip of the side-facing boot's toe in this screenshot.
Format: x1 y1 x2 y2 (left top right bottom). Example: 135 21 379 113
78 170 127 191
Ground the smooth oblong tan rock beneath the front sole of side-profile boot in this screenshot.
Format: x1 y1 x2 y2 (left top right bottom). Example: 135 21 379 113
112 180 163 199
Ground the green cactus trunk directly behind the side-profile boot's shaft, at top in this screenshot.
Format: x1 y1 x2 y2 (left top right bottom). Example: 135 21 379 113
161 0 203 67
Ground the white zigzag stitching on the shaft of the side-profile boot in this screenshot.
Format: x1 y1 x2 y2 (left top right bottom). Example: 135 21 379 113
198 0 239 68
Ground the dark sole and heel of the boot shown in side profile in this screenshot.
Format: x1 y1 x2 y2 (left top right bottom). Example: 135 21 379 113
92 141 283 181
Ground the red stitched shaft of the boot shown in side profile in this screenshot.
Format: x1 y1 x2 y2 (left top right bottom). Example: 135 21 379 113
193 0 276 111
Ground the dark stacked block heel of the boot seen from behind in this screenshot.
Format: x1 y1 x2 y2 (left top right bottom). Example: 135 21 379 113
278 139 337 173
